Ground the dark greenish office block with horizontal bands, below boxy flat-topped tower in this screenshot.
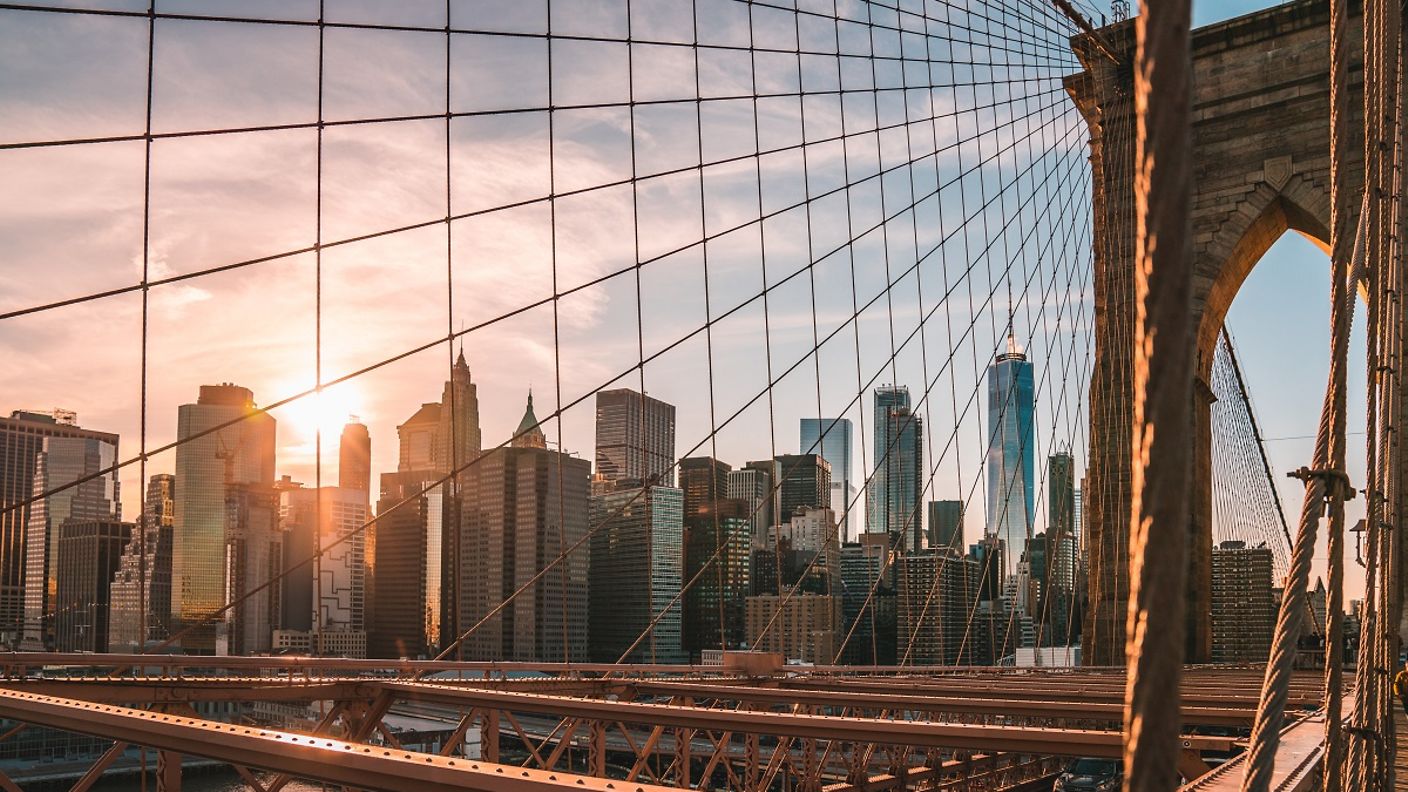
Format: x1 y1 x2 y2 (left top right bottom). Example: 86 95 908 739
589 481 686 662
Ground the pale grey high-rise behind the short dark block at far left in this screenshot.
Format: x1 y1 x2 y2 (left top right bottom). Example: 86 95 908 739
24 416 121 650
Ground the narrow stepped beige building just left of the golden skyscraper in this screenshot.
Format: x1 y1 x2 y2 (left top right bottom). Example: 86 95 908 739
107 474 176 652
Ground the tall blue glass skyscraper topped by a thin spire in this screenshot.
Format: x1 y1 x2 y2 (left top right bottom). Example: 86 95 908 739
987 335 1036 575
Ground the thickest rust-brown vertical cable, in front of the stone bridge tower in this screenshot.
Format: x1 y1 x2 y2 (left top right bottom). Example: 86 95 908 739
1125 0 1194 792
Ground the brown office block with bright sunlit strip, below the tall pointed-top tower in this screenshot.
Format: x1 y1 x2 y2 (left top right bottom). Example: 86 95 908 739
365 470 444 660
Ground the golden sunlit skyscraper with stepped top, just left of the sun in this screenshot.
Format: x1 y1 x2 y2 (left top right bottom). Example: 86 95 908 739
172 383 277 654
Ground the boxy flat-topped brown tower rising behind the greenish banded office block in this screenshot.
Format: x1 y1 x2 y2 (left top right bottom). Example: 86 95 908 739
597 388 674 486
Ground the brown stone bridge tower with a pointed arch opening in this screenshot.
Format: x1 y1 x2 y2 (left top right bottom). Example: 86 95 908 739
1066 0 1363 665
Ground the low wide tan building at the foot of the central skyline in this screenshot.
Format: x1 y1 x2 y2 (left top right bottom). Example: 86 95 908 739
745 592 841 664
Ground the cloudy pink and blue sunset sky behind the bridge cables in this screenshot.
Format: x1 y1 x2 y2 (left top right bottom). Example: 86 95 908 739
0 0 1363 591
